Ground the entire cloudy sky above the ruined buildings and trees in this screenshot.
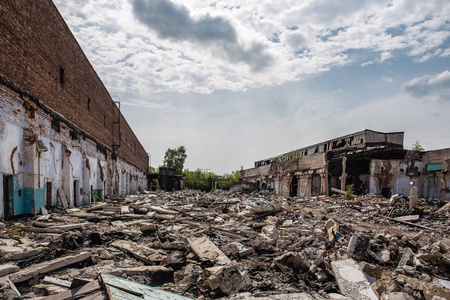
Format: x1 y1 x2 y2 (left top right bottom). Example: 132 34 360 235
54 0 450 174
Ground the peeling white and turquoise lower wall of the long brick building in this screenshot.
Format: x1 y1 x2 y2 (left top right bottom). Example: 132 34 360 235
0 85 147 217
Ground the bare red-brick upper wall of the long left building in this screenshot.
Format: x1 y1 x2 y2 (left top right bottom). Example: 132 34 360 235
0 0 148 170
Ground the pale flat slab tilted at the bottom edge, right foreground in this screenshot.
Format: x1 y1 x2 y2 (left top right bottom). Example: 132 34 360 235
331 259 378 300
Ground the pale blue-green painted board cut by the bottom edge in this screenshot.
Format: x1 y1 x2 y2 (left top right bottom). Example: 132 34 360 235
99 274 190 300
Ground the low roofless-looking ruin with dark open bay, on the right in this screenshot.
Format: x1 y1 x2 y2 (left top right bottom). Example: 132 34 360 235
241 129 450 199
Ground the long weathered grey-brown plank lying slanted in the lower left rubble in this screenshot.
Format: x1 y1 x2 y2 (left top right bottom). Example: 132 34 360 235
10 252 91 283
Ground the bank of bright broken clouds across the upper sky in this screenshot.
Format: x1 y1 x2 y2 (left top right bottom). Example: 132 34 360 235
54 0 450 94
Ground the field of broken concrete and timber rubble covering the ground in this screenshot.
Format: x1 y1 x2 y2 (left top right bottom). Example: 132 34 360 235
0 190 450 300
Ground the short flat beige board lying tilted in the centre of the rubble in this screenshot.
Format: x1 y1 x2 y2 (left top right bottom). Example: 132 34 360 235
187 236 231 265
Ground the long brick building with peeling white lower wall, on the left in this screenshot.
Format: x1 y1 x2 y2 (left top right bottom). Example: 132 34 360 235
0 0 149 218
